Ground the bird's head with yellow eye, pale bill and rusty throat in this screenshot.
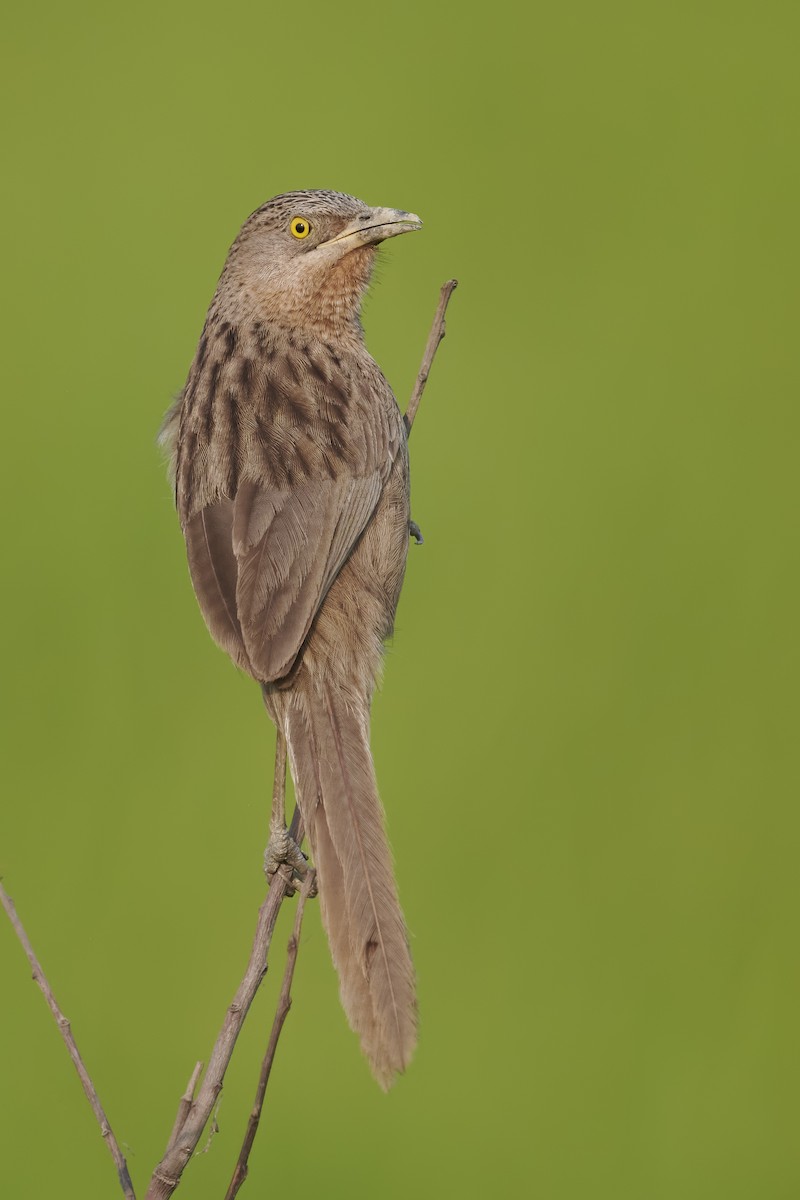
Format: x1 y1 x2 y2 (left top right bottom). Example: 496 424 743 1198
217 191 422 337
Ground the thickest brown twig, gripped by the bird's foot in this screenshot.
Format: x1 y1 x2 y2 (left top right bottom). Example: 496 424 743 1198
145 809 303 1200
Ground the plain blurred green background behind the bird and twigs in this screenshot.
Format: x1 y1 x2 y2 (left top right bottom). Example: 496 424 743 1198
0 0 800 1200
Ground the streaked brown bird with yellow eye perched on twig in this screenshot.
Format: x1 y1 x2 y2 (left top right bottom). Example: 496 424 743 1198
160 190 422 1088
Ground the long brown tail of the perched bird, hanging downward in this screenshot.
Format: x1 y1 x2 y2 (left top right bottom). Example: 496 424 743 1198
282 689 416 1088
